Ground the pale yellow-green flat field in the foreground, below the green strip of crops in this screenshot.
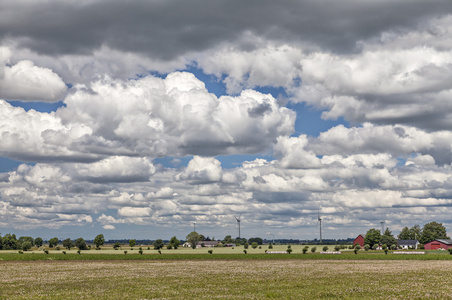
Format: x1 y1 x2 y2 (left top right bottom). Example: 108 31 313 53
0 259 452 299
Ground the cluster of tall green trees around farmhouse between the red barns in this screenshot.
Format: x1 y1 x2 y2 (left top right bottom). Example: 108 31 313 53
364 222 449 248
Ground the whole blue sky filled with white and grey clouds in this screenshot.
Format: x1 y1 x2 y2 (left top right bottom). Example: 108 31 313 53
0 0 452 240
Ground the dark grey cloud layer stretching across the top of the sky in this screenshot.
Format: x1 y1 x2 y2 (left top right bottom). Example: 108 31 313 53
0 0 452 59
